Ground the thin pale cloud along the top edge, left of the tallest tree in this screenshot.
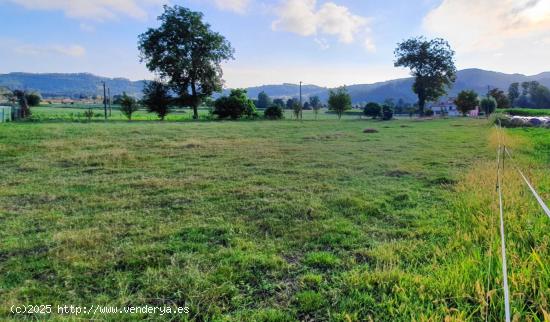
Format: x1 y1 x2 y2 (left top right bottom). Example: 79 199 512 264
5 0 166 21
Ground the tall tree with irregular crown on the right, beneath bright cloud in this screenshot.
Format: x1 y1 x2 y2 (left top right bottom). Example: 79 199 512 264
395 37 456 113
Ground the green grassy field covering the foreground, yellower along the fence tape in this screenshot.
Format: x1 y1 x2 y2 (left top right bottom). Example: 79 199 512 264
0 109 550 321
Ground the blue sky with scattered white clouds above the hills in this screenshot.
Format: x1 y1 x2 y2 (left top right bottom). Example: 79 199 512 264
0 0 550 87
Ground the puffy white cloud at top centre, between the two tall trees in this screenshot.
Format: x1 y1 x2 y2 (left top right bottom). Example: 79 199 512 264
272 0 374 50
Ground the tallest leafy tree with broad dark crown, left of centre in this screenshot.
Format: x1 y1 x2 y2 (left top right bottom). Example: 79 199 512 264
139 5 234 119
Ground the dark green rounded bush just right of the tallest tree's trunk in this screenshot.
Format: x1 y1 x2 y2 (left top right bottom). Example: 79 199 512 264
212 89 258 120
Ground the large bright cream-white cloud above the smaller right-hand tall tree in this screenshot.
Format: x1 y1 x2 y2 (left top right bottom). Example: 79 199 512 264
424 0 550 52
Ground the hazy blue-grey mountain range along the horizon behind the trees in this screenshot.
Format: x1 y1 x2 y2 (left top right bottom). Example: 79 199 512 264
0 69 550 104
